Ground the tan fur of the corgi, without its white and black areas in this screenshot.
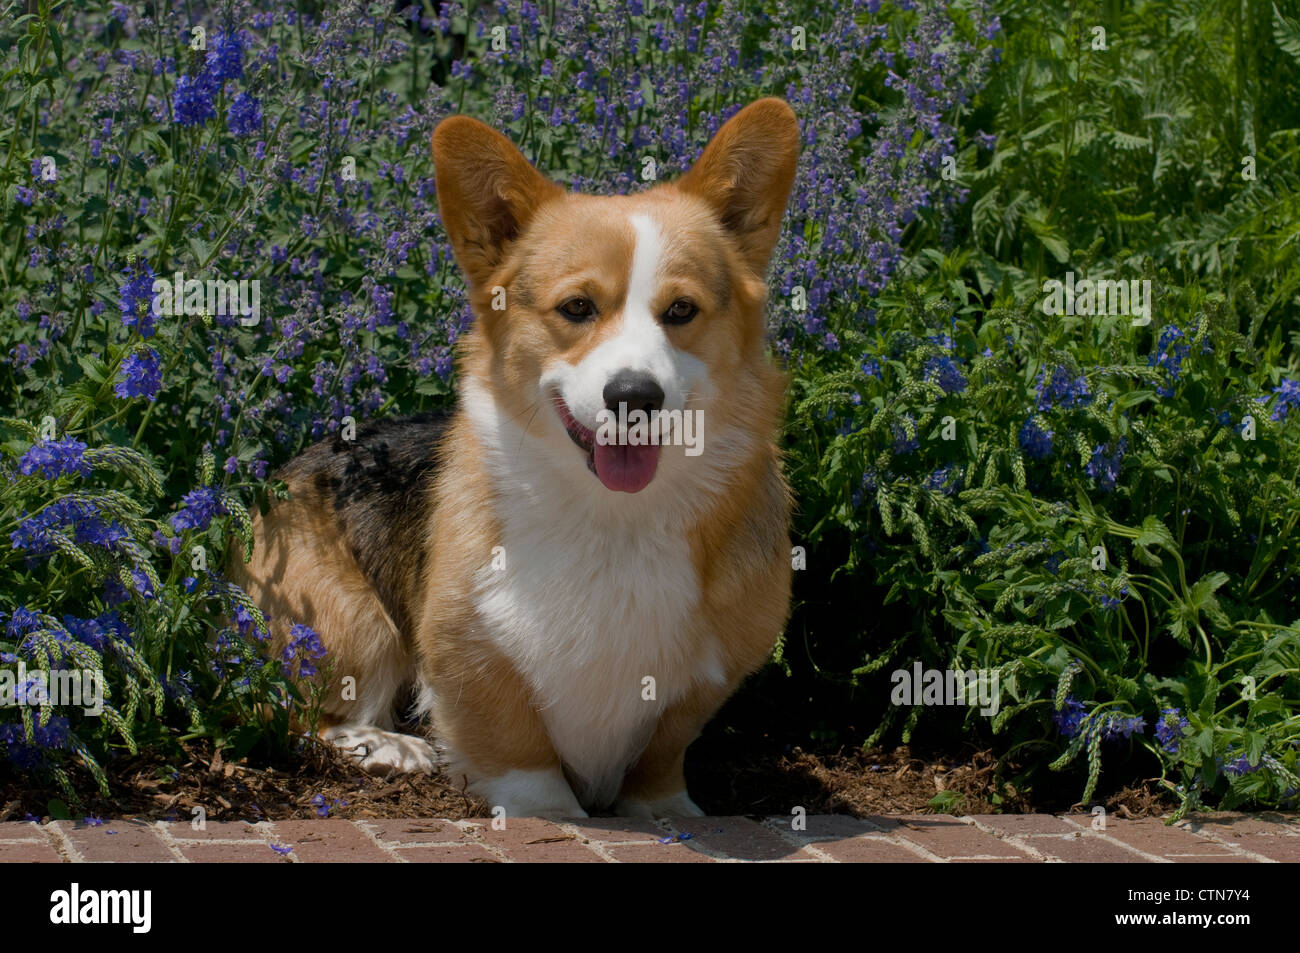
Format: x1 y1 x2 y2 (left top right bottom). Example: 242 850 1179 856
231 100 797 801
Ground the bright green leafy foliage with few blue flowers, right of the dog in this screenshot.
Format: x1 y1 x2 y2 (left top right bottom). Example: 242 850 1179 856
790 3 1300 814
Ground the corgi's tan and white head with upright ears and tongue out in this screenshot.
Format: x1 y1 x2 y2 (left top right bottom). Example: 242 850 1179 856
433 99 798 493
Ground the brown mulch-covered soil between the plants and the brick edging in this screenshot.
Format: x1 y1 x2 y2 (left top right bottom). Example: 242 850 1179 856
0 738 1174 820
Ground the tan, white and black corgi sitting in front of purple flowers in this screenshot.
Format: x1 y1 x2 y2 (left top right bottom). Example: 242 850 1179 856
230 99 800 818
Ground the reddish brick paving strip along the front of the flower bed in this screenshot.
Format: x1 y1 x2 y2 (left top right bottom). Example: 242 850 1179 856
0 814 1300 863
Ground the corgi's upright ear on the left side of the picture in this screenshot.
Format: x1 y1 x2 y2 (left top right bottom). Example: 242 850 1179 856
433 116 564 287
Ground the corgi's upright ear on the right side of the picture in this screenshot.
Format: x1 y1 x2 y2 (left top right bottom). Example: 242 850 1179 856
677 99 800 276
